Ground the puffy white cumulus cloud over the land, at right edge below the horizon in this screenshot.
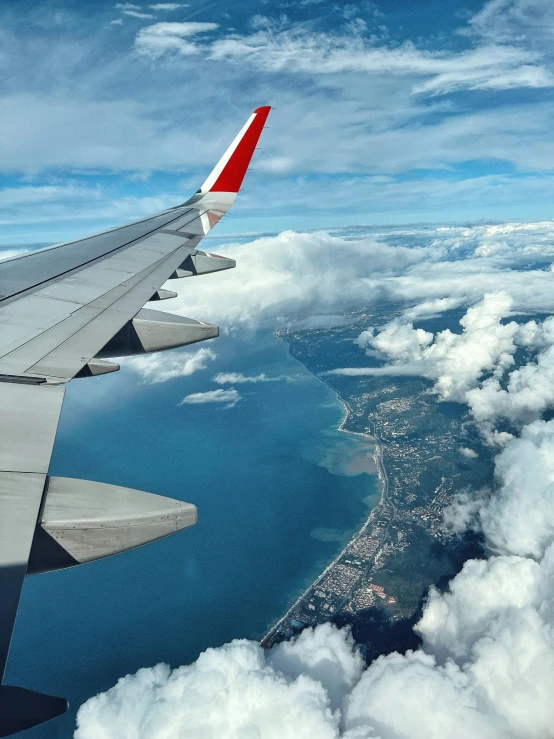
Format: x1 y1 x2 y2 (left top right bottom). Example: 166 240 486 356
331 284 554 443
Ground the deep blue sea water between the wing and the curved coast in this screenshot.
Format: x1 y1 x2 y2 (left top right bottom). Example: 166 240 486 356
7 333 377 739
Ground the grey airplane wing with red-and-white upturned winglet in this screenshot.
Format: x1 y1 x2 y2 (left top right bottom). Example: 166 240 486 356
0 106 270 736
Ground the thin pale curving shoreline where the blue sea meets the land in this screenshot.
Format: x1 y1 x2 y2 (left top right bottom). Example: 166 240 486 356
260 364 386 647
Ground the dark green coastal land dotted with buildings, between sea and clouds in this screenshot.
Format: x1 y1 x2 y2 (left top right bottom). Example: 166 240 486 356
261 307 492 659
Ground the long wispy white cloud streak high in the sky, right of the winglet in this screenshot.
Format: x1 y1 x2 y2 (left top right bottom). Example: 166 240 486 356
204 21 554 94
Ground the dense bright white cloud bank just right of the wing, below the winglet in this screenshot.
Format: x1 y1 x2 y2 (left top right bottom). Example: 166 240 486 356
160 231 422 327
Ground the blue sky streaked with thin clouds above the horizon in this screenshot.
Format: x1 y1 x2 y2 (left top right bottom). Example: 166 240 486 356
0 0 554 245
